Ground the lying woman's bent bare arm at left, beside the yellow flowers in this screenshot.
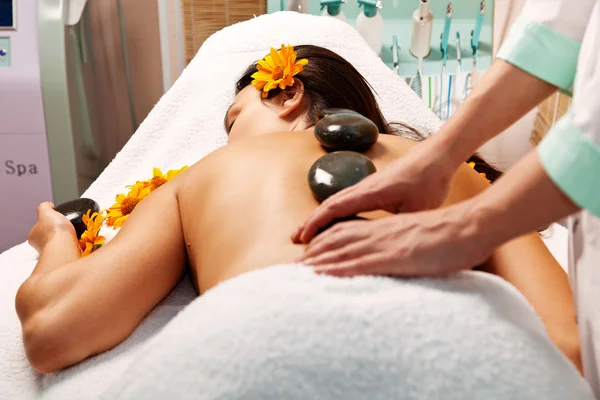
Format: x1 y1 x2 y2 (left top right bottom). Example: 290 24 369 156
16 181 186 373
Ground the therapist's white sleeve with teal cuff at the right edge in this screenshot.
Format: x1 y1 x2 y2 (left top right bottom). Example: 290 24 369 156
538 4 600 216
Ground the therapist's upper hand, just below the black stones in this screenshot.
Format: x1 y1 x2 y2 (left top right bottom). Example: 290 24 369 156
292 142 454 243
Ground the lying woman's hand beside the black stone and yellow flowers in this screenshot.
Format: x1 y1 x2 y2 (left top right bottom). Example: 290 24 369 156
28 202 76 253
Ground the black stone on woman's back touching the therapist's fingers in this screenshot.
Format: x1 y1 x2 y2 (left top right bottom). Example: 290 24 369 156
308 151 377 201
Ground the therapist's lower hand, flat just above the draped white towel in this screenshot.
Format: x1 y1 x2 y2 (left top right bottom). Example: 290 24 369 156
299 207 494 276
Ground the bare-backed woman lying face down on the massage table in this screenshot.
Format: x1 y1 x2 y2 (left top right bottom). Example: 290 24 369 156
16 46 580 372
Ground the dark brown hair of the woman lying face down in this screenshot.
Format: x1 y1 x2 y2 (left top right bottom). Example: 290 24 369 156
236 45 502 182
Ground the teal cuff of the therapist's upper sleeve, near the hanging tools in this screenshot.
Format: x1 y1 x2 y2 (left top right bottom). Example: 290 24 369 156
497 16 581 91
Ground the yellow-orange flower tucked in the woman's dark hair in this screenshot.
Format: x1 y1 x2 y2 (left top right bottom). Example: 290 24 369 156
251 44 308 99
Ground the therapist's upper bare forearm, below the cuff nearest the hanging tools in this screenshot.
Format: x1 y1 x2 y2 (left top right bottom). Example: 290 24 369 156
430 59 556 168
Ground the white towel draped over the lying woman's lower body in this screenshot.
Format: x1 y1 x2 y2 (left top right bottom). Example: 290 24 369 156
103 265 593 400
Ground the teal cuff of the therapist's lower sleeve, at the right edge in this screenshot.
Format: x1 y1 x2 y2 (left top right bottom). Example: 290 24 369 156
538 114 600 217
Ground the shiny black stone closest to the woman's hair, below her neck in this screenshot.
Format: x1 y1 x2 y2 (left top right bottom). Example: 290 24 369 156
315 109 379 152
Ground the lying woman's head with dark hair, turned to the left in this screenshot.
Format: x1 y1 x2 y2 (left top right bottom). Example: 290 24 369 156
225 45 391 140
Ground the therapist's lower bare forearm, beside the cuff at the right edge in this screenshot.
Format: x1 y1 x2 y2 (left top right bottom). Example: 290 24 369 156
467 150 580 247
